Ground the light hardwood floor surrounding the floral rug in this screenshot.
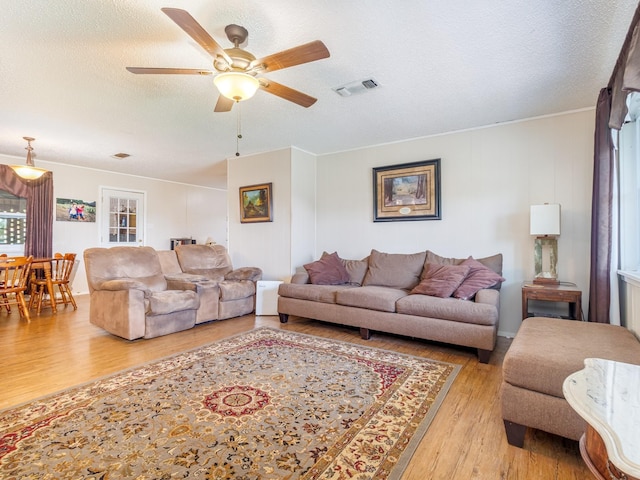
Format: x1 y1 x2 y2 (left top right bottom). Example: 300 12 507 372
0 295 593 480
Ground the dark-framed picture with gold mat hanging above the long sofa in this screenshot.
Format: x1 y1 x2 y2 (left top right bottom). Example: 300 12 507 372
373 158 441 222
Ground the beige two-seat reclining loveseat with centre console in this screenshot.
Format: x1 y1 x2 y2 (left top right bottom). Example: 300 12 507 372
84 245 262 340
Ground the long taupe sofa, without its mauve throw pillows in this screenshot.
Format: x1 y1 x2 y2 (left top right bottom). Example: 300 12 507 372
278 250 504 363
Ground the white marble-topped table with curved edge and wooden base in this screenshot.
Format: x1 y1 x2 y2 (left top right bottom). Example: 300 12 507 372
563 358 640 480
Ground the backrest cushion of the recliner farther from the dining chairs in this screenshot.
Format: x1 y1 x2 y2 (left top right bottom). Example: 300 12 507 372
176 244 233 281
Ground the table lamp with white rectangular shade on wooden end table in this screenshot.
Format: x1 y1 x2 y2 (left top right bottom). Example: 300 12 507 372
530 203 560 285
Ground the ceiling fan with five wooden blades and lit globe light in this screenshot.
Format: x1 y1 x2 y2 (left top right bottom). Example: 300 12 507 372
127 8 329 112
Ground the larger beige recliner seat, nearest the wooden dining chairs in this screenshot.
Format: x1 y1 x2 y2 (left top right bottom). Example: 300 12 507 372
84 247 200 340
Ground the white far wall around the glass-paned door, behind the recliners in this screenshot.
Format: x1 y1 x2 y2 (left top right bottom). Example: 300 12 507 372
0 155 227 293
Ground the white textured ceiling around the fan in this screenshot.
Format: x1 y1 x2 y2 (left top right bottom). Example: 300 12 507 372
0 0 637 187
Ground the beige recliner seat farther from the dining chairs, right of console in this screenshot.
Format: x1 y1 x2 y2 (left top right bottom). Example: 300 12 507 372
170 245 262 323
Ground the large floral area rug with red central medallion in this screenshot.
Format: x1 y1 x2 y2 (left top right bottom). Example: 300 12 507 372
0 328 460 480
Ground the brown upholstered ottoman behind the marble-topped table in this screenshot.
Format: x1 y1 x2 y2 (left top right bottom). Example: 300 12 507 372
501 317 640 447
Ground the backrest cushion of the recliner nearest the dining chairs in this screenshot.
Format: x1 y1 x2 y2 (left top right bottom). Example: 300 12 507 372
84 247 167 292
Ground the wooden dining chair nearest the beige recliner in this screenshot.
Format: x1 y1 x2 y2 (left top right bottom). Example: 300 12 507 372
29 253 78 314
